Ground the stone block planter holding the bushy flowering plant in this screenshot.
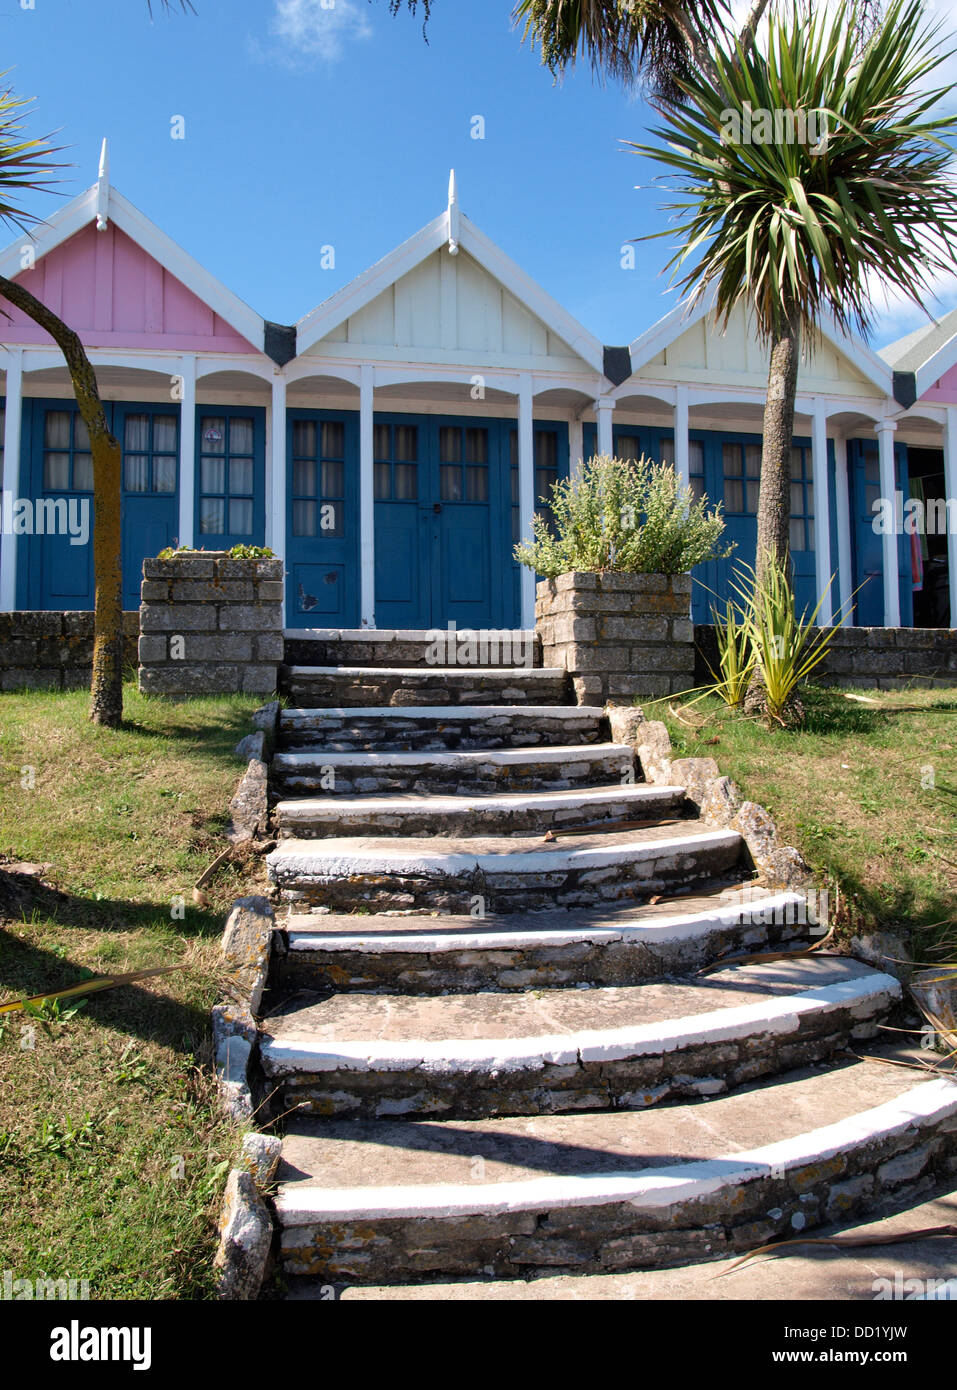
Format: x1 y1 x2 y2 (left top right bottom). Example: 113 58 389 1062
536 573 694 705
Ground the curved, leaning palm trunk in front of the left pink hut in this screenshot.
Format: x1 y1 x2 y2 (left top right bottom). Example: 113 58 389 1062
0 275 122 728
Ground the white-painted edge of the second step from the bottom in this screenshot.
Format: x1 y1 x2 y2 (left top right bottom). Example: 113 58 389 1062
262 972 900 1077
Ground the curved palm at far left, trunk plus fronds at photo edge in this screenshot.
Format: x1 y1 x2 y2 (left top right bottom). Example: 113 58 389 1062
0 89 122 728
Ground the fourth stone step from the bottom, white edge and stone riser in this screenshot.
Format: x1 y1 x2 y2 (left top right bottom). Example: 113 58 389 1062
266 821 743 912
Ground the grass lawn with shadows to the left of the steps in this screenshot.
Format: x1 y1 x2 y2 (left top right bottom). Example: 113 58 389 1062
0 685 260 1300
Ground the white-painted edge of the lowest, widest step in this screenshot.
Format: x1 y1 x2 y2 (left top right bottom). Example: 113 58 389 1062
275 1079 957 1229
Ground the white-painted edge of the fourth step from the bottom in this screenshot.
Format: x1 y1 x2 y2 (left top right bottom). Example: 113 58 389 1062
266 821 741 878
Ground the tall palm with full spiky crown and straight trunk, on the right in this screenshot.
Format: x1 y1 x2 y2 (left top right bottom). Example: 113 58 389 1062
629 0 957 578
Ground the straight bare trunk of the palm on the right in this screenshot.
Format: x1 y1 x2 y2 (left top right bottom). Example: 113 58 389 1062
755 313 801 582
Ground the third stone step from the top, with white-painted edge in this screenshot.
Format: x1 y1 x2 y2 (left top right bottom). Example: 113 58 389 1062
278 705 605 753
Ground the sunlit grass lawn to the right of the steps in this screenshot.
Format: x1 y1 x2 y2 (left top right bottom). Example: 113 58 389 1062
656 685 957 960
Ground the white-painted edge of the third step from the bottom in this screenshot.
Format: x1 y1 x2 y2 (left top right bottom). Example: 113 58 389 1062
286 888 805 955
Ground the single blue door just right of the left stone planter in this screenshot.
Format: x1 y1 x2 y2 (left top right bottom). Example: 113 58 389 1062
285 410 359 627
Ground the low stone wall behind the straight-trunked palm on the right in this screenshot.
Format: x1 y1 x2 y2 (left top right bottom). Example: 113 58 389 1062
694 623 957 689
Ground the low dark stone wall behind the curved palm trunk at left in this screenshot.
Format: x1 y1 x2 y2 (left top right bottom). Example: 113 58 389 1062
0 612 139 691
